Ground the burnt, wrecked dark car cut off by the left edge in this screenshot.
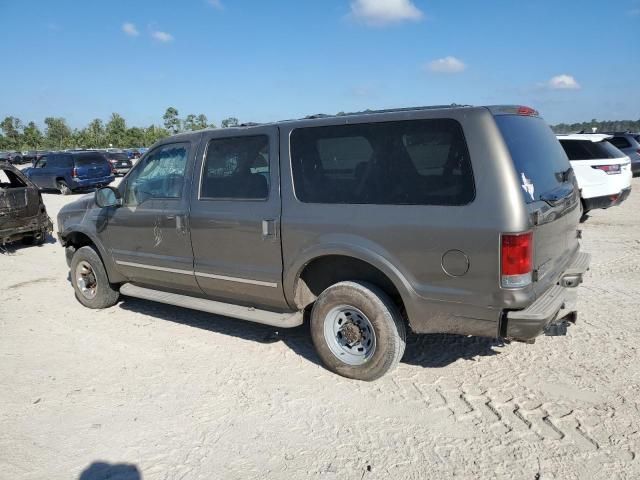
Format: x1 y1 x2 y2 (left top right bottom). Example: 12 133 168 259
0 161 53 245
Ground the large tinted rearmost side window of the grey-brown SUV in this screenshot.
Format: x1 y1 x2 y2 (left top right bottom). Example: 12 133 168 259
291 119 475 205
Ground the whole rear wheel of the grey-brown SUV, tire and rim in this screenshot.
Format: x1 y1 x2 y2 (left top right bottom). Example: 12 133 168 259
311 282 406 381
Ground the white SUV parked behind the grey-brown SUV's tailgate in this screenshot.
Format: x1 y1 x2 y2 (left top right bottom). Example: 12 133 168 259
558 133 631 213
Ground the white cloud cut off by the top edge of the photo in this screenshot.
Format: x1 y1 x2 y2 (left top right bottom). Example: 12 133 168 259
351 0 424 26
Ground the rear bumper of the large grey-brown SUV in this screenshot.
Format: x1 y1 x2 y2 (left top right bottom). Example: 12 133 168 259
500 252 591 341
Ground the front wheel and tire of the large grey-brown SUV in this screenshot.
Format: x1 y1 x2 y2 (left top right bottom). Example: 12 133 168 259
71 246 120 308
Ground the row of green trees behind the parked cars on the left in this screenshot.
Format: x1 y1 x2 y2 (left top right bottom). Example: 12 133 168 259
0 107 238 151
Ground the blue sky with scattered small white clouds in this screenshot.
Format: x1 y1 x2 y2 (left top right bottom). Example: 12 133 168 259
0 0 640 127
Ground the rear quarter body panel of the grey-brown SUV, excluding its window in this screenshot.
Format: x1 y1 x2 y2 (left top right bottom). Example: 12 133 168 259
280 108 529 335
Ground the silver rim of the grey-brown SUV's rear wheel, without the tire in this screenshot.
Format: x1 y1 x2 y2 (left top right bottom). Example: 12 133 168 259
324 305 376 365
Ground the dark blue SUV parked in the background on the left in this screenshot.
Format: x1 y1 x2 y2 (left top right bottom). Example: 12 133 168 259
24 151 114 195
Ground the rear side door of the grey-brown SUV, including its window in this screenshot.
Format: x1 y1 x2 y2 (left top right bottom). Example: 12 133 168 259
190 127 287 309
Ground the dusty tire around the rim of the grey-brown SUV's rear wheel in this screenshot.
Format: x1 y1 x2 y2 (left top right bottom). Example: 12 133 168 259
311 282 406 381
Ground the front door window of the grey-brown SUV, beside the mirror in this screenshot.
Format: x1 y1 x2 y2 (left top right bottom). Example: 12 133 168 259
124 143 189 205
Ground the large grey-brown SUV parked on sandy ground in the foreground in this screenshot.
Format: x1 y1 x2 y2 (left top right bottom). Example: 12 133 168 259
58 106 589 380
